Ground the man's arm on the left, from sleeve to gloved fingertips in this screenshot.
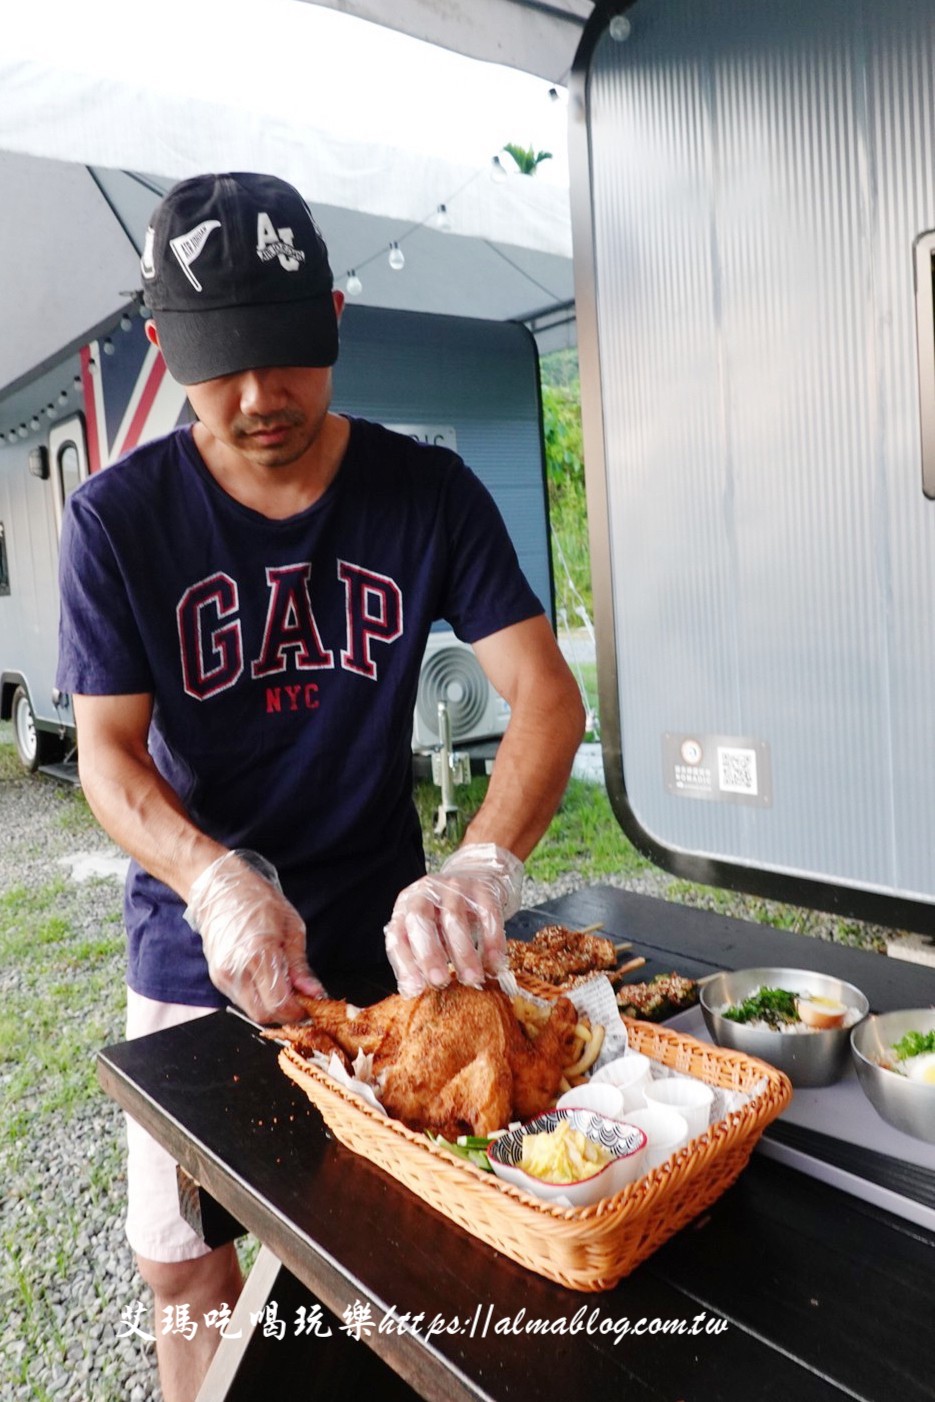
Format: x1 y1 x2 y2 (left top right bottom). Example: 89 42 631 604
73 694 324 1022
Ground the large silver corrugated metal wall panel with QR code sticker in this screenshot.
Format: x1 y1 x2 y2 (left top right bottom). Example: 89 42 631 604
587 0 935 899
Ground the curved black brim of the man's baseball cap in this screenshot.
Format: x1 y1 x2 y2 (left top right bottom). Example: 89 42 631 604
154 292 338 384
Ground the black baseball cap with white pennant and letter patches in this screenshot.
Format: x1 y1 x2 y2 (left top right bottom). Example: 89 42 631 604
140 171 338 384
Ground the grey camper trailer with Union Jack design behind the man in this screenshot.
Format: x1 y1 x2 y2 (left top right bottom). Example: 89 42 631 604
0 306 554 771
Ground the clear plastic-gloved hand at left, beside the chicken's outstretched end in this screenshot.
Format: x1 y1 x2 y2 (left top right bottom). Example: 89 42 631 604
184 850 324 1022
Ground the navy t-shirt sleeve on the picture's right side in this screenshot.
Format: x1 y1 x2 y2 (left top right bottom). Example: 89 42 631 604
443 460 545 642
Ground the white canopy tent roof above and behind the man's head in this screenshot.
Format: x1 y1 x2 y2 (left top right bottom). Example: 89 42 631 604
0 0 592 390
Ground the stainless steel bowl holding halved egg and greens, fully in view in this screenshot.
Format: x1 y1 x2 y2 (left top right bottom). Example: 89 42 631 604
701 969 869 1085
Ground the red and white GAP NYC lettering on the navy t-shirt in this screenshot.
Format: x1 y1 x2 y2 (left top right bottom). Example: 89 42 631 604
175 559 402 709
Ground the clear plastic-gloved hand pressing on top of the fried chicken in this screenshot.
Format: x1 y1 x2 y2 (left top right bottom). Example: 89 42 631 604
384 843 524 998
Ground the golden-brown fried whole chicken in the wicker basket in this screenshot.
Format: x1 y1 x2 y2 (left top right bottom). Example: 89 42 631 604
272 983 578 1138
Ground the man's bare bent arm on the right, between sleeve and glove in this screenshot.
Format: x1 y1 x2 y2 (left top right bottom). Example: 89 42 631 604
464 615 585 861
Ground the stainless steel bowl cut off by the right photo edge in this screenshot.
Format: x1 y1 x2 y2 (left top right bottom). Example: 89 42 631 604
851 1008 935 1144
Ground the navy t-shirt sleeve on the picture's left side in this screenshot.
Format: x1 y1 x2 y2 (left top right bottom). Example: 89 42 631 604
56 492 154 695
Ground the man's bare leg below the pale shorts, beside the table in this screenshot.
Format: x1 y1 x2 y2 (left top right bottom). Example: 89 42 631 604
136 1244 244 1402
